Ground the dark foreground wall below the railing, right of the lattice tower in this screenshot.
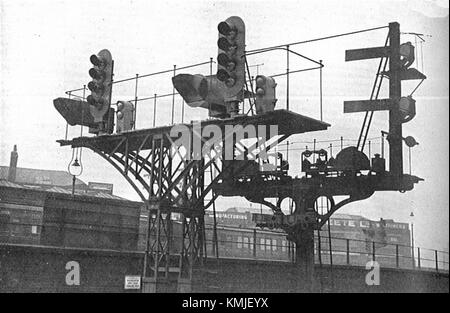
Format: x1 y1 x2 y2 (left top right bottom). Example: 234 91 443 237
193 259 449 293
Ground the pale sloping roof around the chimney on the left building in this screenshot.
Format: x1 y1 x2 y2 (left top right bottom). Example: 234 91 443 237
0 166 87 187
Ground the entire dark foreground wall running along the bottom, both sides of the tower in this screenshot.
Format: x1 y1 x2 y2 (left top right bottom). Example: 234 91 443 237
0 245 449 293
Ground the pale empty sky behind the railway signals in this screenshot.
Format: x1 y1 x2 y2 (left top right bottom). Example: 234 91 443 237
0 0 449 250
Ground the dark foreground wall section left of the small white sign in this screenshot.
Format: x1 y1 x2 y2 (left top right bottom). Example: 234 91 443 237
0 245 142 292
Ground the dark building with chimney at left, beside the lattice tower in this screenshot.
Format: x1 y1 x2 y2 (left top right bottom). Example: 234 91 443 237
0 147 142 250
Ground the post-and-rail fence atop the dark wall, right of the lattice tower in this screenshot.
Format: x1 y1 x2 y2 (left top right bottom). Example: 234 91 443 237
195 225 449 272
